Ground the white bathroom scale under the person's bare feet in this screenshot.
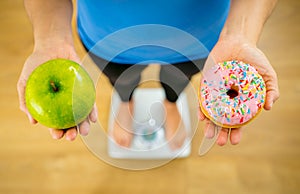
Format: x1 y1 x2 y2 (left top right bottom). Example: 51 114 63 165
108 88 191 159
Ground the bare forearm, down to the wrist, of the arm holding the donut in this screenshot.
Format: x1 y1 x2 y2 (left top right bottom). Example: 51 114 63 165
220 0 277 44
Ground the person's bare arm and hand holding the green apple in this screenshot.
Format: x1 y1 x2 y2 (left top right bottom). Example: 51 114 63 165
17 0 97 140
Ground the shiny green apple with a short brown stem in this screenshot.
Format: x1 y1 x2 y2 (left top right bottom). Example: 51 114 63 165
25 59 96 129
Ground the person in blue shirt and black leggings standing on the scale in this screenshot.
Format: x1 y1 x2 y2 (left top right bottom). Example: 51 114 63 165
18 0 279 149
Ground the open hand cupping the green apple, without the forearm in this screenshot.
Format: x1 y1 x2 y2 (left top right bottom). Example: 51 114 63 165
17 42 97 141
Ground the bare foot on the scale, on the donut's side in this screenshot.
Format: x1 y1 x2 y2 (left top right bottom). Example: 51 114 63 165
164 100 187 150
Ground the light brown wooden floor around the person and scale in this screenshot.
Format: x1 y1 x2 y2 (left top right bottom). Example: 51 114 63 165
0 0 300 194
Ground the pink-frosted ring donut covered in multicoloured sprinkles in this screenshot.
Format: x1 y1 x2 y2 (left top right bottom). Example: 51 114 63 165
199 60 266 128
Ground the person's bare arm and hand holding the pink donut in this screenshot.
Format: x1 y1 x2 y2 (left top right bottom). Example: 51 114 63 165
199 0 279 145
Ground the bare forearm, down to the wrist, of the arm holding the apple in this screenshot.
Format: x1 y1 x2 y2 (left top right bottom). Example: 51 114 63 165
24 0 73 47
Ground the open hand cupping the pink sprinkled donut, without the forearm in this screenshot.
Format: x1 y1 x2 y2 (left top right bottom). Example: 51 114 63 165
199 37 279 146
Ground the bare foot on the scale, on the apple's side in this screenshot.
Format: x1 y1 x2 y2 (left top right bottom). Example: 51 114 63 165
112 101 133 147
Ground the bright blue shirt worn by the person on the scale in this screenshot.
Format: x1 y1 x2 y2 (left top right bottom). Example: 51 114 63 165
77 0 230 64
